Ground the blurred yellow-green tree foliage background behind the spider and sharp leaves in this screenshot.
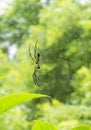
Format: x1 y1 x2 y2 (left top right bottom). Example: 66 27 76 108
0 0 91 130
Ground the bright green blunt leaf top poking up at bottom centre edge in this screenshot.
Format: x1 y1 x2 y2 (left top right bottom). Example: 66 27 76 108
32 120 58 130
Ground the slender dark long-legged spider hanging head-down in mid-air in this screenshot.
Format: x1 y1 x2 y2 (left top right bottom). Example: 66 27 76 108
29 41 40 86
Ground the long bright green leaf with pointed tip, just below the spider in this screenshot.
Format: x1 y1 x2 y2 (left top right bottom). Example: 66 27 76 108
0 93 48 114
